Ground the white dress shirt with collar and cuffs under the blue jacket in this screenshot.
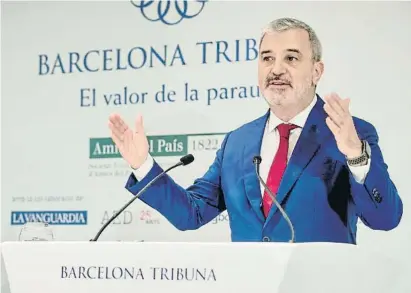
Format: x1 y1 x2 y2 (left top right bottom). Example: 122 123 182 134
133 96 370 196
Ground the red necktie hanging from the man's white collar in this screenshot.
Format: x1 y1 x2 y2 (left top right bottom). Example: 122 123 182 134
263 124 297 218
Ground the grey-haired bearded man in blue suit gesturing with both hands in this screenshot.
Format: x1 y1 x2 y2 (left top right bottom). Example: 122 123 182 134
109 18 403 244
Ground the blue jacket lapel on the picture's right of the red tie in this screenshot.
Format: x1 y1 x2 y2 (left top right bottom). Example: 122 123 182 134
266 97 329 223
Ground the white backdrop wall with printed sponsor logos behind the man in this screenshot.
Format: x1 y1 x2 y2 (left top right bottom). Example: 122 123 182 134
1 1 411 257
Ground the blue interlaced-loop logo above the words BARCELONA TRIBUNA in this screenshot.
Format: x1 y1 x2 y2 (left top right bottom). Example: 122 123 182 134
131 0 207 25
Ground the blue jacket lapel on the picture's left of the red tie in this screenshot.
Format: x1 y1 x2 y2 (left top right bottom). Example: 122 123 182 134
243 111 270 222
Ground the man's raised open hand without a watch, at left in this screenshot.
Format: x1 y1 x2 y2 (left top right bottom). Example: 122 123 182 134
108 114 148 169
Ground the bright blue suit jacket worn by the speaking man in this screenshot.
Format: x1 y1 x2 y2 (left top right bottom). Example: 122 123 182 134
126 97 403 243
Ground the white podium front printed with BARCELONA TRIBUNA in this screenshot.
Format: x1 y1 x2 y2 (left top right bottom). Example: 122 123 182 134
2 242 410 293
